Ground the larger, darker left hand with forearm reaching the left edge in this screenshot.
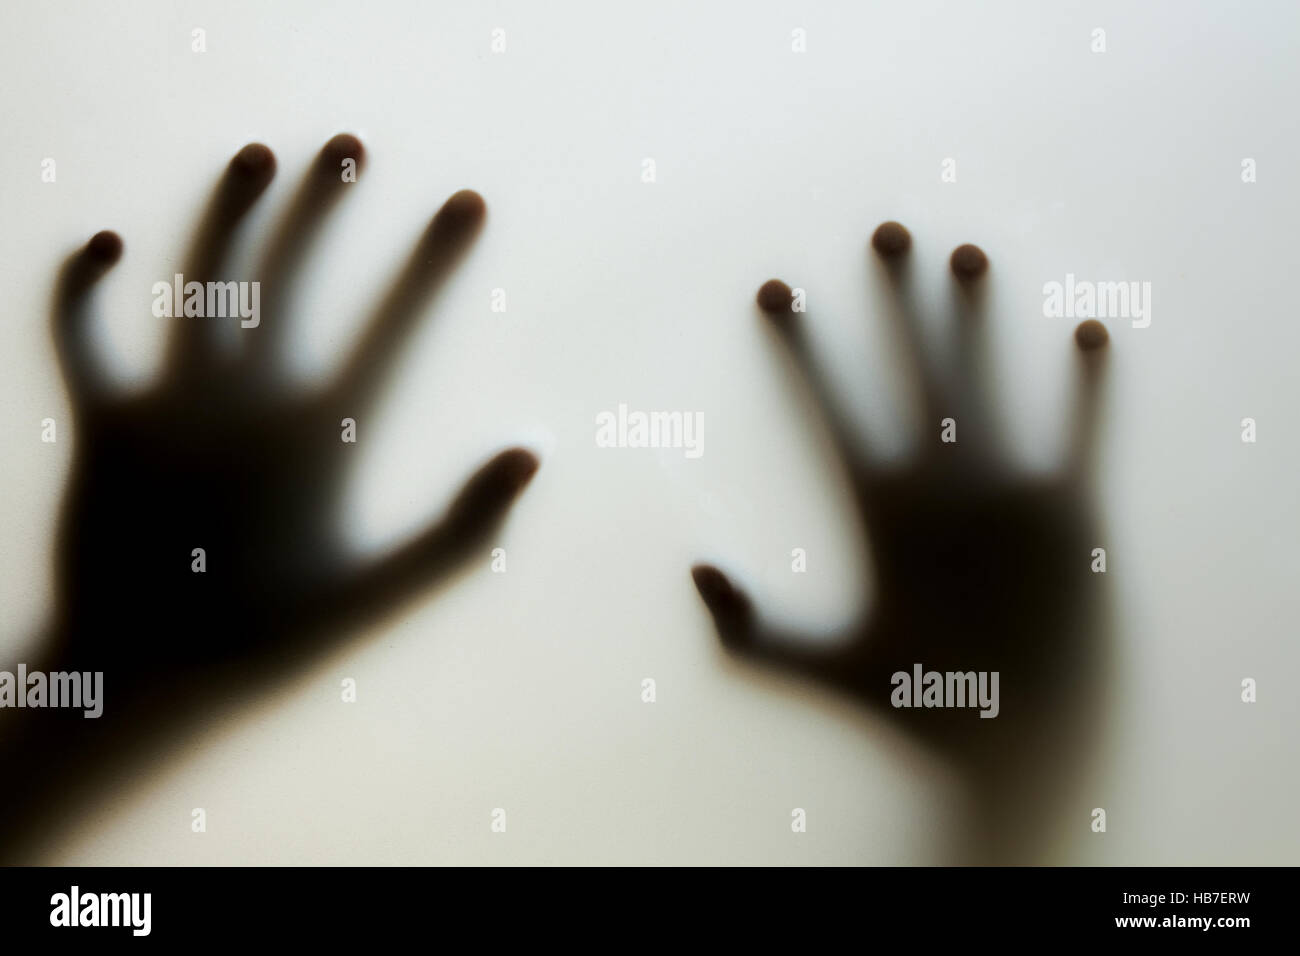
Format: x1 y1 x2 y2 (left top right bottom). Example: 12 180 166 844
0 135 538 862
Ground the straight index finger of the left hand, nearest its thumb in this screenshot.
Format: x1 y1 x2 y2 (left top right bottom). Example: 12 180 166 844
325 190 488 406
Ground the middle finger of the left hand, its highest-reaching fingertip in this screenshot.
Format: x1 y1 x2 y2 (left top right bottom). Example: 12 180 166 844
247 133 365 373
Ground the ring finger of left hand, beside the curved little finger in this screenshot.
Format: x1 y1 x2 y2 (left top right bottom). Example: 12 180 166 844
166 143 276 380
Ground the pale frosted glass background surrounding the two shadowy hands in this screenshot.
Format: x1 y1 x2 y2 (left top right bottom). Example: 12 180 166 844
0 0 1300 864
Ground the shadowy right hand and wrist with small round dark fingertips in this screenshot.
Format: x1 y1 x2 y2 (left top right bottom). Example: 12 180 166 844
693 222 1108 861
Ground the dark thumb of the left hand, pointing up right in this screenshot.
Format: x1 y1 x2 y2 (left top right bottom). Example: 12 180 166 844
313 447 540 629
